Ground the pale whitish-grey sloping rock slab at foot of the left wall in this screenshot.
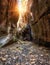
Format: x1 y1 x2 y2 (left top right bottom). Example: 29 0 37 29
0 34 12 47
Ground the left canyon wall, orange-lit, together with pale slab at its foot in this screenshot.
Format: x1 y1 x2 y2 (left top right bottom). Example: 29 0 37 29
0 0 19 47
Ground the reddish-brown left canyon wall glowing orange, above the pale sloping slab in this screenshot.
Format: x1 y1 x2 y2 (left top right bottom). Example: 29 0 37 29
0 0 19 33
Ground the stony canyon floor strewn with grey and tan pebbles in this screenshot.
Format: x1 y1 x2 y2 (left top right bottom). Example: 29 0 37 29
0 41 50 65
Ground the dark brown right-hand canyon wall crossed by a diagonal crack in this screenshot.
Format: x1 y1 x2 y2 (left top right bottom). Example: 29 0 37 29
31 0 50 42
